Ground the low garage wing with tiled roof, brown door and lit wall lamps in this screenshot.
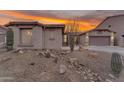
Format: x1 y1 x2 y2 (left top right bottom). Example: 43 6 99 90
80 29 116 46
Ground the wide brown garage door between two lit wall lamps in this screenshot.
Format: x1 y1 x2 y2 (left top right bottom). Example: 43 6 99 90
89 36 110 46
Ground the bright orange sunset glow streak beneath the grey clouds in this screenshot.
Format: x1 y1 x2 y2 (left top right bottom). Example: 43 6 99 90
0 10 100 31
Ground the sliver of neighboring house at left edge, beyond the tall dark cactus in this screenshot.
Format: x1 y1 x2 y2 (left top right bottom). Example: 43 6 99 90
0 26 8 48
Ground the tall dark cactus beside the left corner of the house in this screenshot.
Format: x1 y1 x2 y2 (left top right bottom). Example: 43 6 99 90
6 29 14 51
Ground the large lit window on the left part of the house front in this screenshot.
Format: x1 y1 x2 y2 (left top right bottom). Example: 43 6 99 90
20 28 32 45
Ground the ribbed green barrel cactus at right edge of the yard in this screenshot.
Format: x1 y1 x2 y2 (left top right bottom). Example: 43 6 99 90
111 53 122 74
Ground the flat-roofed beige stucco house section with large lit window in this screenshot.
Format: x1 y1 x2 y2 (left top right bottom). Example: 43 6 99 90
6 22 64 49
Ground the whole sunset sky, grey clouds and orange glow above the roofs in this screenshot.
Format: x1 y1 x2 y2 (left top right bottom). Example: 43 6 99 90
0 10 124 31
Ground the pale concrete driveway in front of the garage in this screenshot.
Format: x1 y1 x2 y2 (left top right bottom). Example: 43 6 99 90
85 46 124 56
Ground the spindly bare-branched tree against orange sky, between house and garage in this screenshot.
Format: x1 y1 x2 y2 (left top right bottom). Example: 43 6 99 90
65 20 79 51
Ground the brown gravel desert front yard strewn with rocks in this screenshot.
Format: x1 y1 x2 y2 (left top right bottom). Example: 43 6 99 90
0 49 118 82
